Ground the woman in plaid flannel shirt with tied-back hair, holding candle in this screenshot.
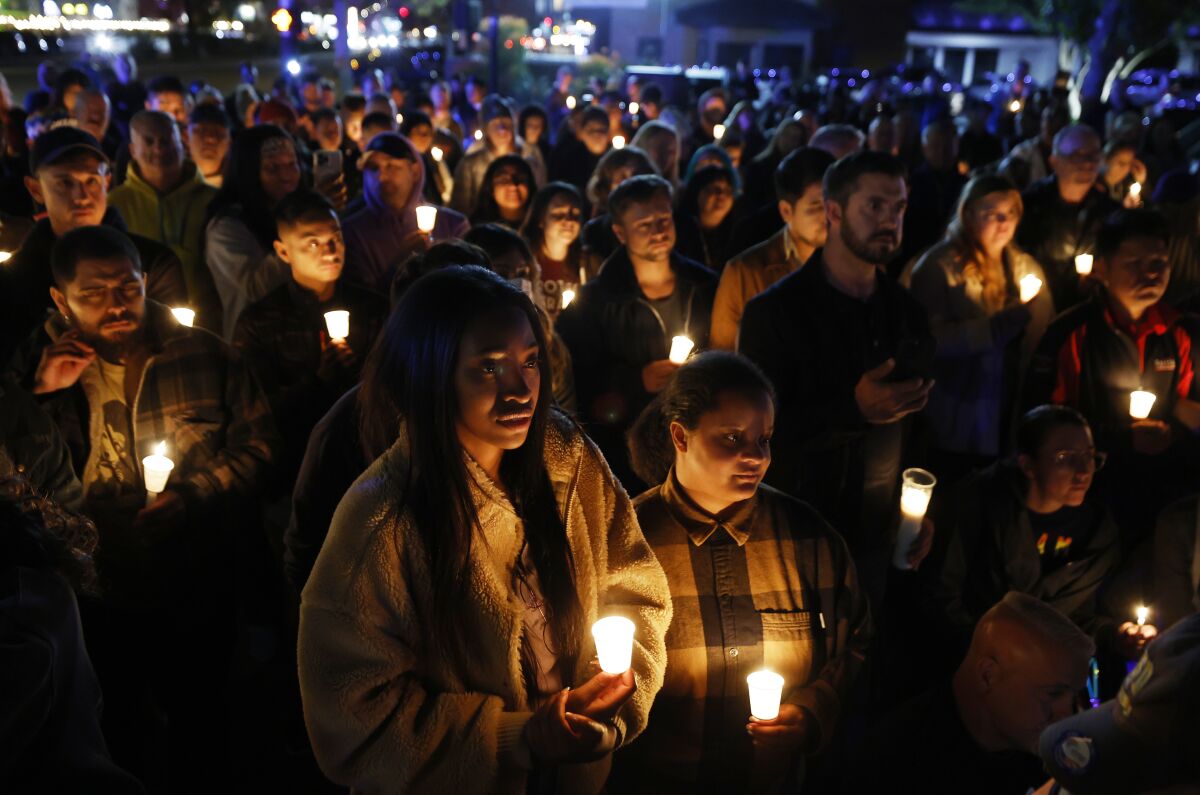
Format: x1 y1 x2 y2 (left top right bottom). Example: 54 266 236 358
610 351 871 793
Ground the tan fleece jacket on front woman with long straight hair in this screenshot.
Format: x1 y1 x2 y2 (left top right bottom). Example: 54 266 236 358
299 414 671 794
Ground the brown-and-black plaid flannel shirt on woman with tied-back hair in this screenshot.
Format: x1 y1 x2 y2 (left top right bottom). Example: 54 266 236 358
614 472 871 793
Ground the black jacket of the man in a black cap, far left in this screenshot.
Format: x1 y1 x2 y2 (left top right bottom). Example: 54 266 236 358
0 208 188 361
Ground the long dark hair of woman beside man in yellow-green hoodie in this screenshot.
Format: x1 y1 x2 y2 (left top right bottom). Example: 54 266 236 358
209 124 295 251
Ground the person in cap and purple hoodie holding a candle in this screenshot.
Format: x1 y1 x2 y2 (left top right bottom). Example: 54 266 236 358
342 132 470 293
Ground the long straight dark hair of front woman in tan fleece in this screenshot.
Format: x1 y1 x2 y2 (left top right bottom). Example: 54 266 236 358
359 265 583 670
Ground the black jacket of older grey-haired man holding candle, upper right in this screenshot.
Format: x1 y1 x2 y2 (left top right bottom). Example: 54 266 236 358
1016 175 1121 310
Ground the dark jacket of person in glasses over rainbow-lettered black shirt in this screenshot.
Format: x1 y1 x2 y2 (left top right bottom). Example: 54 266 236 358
930 461 1121 651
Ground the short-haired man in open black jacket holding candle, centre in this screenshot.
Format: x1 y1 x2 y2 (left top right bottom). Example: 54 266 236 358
556 175 716 492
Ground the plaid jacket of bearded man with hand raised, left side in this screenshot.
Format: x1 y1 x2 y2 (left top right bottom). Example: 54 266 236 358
13 300 280 506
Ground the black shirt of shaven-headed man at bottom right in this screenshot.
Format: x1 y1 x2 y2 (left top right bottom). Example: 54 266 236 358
842 682 1050 795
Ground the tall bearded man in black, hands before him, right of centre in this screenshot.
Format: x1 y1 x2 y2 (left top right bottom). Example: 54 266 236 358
738 151 935 598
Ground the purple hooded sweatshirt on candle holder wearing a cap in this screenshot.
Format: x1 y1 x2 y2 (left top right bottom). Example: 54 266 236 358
342 138 470 294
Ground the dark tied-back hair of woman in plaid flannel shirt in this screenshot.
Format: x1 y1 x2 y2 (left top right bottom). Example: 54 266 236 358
625 351 779 484
